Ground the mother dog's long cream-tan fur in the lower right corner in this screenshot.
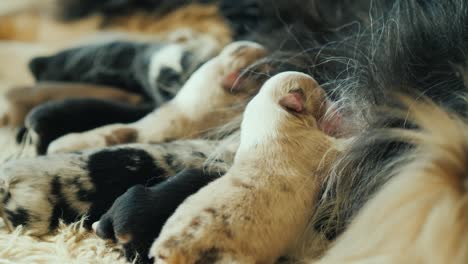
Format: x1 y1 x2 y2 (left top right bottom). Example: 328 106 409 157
309 100 468 264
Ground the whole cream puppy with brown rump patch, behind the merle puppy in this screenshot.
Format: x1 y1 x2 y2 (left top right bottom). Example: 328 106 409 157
48 41 266 153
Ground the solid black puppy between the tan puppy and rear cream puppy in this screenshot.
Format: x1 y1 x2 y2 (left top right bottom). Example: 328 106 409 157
23 98 153 155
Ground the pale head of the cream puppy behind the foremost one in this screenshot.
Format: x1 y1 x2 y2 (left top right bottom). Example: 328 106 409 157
174 41 266 119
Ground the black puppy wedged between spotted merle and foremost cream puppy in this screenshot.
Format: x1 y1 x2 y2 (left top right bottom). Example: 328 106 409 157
93 169 220 263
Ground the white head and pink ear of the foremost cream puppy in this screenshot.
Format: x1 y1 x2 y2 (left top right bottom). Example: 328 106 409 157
241 72 326 151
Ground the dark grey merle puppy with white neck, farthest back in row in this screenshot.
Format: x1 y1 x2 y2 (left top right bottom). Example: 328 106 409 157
29 38 219 105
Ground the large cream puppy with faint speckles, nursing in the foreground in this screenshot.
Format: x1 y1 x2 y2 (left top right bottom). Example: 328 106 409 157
150 72 337 263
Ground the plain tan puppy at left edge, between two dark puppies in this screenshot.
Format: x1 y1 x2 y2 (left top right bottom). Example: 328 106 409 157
0 82 143 127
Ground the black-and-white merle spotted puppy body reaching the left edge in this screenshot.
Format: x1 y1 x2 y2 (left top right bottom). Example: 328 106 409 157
0 140 225 235
